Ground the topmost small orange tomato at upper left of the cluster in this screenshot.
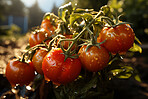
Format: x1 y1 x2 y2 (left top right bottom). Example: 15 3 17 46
41 18 57 36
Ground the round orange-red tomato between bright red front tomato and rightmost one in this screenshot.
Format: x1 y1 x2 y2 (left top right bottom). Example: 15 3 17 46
79 45 109 72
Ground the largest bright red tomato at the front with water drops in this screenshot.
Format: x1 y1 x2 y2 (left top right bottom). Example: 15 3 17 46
42 48 81 84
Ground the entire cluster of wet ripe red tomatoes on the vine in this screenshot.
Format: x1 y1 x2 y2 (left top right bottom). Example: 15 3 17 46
6 5 135 86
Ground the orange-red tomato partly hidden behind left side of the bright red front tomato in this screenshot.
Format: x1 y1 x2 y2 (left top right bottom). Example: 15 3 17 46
32 49 48 74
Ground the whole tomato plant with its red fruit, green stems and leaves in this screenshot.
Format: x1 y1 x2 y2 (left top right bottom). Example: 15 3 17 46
3 3 142 99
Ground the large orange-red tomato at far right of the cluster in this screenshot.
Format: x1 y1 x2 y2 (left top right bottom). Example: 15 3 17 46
97 24 135 54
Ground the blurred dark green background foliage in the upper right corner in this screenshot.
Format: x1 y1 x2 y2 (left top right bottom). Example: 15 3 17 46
108 0 148 41
